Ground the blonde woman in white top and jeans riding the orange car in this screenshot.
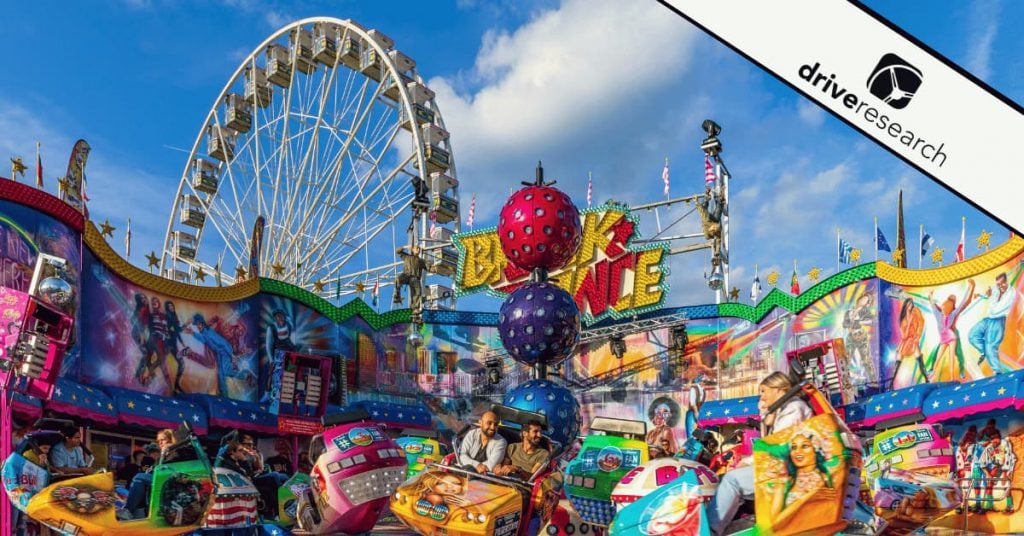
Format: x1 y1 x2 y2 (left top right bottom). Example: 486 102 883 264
708 371 814 534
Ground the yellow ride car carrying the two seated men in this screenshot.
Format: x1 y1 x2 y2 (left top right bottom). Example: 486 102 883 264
391 405 561 536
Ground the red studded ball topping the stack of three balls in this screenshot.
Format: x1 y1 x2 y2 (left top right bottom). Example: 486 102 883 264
498 164 583 271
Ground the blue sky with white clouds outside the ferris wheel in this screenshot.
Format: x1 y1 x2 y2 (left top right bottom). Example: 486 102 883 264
0 0 1024 310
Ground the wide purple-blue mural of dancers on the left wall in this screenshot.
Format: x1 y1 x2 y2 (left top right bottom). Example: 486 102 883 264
79 254 259 402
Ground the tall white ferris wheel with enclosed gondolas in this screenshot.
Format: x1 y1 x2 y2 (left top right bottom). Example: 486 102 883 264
161 17 460 303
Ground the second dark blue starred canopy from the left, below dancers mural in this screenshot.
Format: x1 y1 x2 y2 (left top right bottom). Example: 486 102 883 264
108 387 208 436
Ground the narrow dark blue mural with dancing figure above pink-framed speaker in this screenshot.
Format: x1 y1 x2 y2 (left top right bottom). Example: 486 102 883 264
257 295 338 403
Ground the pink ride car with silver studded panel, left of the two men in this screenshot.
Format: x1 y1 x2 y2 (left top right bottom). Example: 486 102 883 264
296 409 409 534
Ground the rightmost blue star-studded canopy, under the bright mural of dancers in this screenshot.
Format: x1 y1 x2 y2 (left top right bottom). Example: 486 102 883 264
924 370 1024 423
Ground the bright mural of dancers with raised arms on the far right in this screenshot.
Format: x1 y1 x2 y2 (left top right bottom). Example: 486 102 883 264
879 255 1024 388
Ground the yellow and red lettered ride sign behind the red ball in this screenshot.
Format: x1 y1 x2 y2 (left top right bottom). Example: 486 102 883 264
453 205 669 324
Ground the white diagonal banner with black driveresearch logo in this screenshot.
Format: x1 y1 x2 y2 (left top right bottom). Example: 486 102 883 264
659 0 1024 233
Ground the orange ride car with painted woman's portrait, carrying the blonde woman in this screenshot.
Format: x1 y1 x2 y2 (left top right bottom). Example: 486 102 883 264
610 364 878 536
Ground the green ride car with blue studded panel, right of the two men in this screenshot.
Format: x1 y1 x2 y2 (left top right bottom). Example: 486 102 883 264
565 417 649 527
